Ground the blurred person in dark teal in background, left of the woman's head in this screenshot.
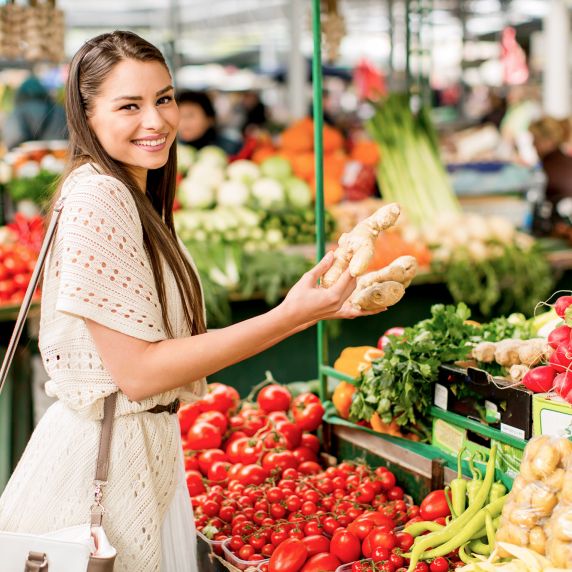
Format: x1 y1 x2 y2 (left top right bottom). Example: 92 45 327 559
3 75 68 149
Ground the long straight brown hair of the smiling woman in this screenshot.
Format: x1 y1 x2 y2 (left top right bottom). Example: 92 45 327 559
55 31 206 338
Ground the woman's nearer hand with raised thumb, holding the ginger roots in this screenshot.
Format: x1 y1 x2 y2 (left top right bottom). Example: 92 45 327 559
282 252 366 326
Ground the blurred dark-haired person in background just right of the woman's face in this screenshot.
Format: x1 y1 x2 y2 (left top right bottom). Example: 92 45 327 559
176 91 241 155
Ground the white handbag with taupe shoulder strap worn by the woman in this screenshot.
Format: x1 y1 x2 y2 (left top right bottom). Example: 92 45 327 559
0 199 117 572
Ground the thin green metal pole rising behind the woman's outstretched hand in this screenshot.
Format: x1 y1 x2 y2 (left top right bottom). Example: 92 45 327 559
312 0 328 400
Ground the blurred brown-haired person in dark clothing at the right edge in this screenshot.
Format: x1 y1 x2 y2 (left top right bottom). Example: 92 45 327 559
529 116 572 238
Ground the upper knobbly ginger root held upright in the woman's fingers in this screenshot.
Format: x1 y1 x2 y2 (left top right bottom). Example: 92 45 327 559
321 203 401 288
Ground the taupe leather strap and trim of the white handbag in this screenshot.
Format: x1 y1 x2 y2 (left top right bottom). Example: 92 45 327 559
0 194 117 572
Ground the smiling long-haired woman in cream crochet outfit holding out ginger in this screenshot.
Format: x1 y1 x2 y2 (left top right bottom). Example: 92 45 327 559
0 32 380 572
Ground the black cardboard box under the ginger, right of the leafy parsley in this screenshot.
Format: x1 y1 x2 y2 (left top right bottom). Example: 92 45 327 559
433 365 534 439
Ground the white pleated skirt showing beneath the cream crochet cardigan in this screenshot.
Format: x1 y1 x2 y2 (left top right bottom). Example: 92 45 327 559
161 437 199 572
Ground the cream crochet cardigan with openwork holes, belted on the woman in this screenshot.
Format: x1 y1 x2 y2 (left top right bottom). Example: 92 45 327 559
0 164 206 572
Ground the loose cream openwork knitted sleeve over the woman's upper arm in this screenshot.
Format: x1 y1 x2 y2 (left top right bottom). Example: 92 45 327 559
56 175 166 342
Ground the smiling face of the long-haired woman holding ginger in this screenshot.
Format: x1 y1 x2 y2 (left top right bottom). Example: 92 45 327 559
88 60 179 189
